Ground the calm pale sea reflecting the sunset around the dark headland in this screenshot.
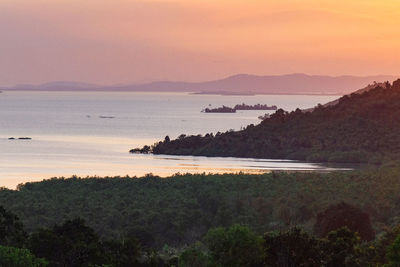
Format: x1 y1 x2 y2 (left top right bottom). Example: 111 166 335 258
0 91 344 187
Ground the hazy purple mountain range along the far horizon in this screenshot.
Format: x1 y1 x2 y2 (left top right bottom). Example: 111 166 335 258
2 74 397 95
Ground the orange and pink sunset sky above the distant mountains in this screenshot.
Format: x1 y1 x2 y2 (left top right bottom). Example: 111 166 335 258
0 0 400 86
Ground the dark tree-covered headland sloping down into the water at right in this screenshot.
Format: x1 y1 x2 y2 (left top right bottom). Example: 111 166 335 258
141 80 400 163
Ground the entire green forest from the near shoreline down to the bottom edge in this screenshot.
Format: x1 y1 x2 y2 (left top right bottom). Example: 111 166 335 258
0 165 400 266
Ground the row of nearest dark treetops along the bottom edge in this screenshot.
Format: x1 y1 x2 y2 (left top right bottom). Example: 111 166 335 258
0 186 400 267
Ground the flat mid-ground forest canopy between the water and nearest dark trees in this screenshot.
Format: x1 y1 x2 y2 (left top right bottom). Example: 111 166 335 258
0 167 400 247
